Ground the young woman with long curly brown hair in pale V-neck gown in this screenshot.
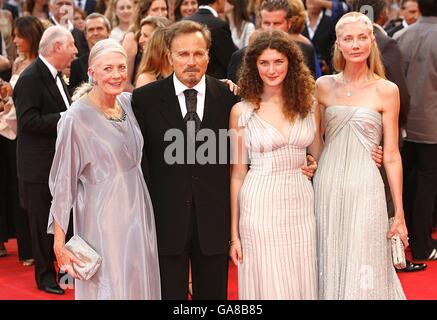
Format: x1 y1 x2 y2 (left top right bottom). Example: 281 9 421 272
229 30 320 300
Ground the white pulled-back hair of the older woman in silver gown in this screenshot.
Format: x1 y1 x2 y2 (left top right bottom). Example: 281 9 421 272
72 38 127 101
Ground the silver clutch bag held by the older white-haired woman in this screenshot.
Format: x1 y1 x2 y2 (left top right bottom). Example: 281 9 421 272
65 235 102 280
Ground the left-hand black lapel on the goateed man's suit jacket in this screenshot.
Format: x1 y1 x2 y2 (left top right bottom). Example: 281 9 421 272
159 74 185 130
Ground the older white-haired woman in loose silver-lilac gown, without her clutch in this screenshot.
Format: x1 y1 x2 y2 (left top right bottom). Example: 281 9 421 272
48 39 161 299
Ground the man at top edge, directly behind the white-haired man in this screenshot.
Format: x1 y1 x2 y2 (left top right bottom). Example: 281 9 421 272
49 0 89 57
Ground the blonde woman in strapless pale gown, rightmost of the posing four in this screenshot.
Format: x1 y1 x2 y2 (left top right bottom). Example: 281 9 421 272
314 12 408 300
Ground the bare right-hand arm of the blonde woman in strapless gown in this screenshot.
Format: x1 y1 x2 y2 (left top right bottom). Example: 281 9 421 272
378 81 408 247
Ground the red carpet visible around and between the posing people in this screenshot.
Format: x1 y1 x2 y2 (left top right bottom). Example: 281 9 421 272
0 233 437 300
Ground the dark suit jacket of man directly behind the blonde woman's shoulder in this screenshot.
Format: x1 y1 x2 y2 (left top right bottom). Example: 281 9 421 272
373 27 410 127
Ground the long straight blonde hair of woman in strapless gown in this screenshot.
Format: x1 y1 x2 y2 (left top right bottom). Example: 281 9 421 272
332 12 386 79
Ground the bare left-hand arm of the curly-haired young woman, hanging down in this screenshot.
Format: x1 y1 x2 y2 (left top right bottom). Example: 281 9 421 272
229 104 248 265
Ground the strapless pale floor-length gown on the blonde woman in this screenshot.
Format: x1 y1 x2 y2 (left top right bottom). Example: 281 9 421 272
314 106 405 300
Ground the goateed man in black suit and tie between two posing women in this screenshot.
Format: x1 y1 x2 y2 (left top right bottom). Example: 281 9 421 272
132 21 237 299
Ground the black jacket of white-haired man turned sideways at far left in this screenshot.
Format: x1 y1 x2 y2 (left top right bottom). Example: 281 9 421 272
13 58 66 184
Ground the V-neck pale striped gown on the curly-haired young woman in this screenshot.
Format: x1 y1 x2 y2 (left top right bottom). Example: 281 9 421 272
238 102 317 299
